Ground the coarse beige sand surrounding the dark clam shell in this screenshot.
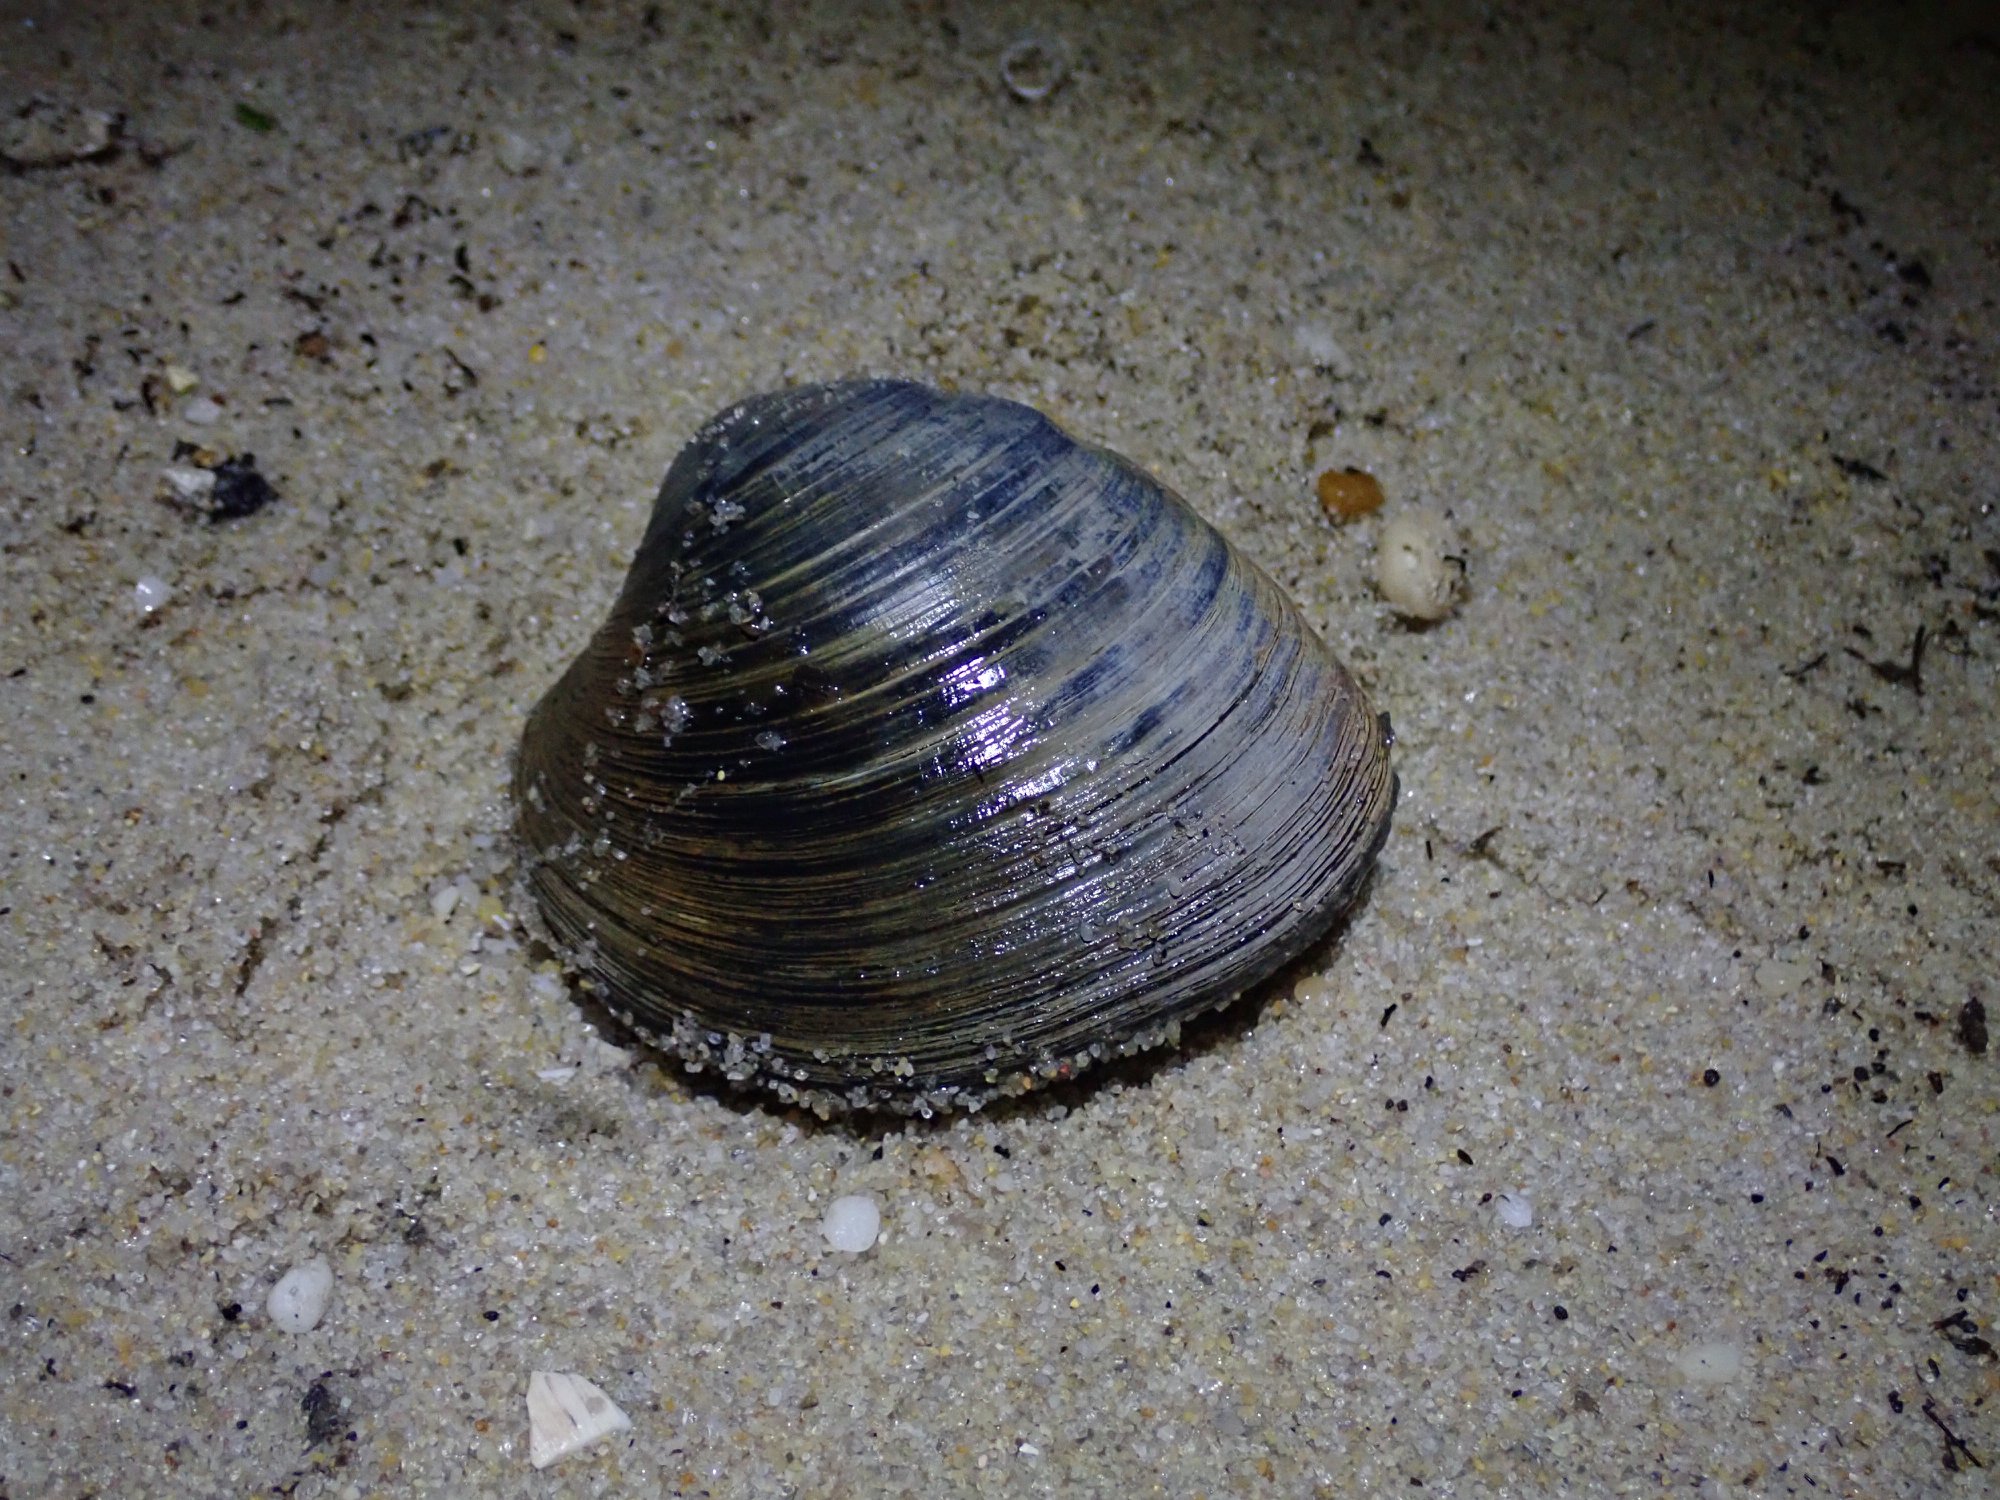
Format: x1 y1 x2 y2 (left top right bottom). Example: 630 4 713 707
0 0 2000 1498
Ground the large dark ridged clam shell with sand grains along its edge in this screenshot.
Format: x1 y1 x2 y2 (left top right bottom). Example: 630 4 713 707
514 380 1396 1114
